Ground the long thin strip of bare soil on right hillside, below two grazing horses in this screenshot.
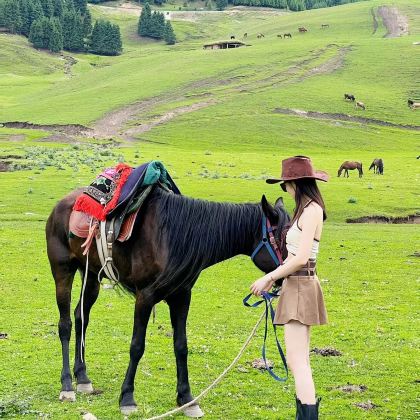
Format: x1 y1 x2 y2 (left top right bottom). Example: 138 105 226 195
274 108 420 131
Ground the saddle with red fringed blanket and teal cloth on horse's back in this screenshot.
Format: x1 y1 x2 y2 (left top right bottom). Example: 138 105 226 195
69 161 181 282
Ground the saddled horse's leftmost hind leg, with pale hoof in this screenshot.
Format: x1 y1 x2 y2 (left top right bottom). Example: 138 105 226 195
48 239 77 401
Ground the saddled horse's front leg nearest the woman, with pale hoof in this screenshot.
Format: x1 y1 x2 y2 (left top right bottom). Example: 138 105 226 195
166 290 204 417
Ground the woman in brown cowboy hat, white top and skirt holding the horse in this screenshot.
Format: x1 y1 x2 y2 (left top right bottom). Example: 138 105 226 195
251 156 329 420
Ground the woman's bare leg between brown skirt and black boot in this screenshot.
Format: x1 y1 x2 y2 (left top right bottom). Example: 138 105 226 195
284 321 316 404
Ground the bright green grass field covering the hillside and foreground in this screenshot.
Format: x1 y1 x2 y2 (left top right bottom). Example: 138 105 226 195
0 0 420 420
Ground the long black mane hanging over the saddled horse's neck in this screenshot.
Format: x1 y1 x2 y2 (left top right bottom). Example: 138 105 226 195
152 189 262 289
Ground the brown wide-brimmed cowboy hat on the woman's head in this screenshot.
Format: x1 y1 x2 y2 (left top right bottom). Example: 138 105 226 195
266 156 329 184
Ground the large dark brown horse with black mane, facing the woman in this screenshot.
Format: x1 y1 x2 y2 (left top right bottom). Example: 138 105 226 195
46 187 289 414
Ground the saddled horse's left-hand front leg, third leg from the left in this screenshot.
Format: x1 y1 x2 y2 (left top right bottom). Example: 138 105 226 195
120 292 155 415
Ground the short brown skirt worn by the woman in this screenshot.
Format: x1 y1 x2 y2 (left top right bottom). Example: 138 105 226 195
273 274 328 325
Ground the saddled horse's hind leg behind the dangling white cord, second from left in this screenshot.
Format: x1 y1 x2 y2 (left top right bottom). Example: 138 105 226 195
73 273 100 393
